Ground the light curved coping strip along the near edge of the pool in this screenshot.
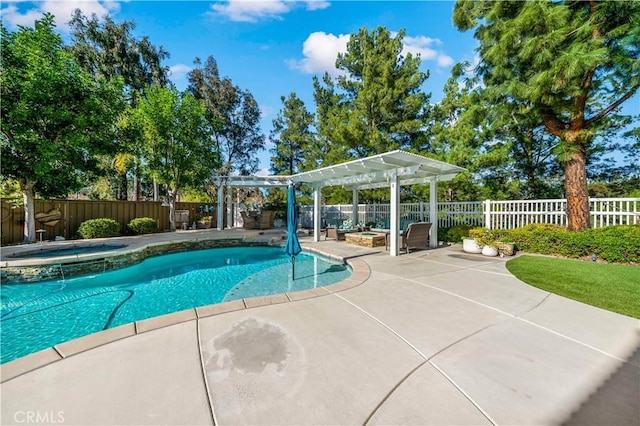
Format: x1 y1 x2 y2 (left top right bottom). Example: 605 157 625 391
0 243 371 383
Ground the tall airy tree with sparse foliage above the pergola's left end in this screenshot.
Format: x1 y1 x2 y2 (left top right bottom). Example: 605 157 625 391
187 56 265 196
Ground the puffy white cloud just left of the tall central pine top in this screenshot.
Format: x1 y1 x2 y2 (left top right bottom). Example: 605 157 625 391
287 31 351 76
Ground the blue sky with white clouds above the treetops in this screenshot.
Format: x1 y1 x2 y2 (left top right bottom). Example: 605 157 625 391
1 0 640 175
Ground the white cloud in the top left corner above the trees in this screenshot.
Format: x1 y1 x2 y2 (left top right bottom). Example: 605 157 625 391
2 0 120 31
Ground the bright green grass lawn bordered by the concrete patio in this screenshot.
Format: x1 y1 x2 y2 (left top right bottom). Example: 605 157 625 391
507 256 640 318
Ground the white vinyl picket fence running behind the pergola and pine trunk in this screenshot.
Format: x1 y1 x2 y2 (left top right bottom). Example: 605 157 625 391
300 198 640 229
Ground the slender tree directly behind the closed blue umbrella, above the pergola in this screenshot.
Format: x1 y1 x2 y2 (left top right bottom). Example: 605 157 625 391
269 92 313 175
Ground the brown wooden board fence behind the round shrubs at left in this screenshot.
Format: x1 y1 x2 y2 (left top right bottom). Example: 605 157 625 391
0 199 220 245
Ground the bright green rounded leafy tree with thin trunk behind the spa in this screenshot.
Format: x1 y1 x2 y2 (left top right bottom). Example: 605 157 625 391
137 86 219 231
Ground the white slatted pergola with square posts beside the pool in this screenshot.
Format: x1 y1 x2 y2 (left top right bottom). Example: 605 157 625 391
218 150 466 256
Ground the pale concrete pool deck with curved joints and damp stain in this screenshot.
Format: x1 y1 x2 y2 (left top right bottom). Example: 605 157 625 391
0 230 640 425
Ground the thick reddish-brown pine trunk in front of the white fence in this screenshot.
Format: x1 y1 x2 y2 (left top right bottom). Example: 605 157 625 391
564 149 589 231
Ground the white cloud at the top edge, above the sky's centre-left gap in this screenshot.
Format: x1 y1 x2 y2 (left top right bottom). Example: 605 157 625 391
211 0 293 22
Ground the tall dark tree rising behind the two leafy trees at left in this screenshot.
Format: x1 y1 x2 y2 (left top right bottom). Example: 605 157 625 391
69 9 169 200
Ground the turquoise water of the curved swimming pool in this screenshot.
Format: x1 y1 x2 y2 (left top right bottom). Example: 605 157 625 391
0 247 351 363
